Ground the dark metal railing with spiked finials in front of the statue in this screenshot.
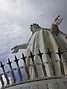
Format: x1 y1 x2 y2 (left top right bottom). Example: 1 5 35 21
0 48 67 87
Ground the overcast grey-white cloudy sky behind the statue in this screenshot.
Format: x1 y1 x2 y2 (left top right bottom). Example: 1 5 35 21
0 0 67 61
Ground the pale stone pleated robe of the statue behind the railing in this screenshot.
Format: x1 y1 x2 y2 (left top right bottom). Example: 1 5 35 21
24 28 67 89
